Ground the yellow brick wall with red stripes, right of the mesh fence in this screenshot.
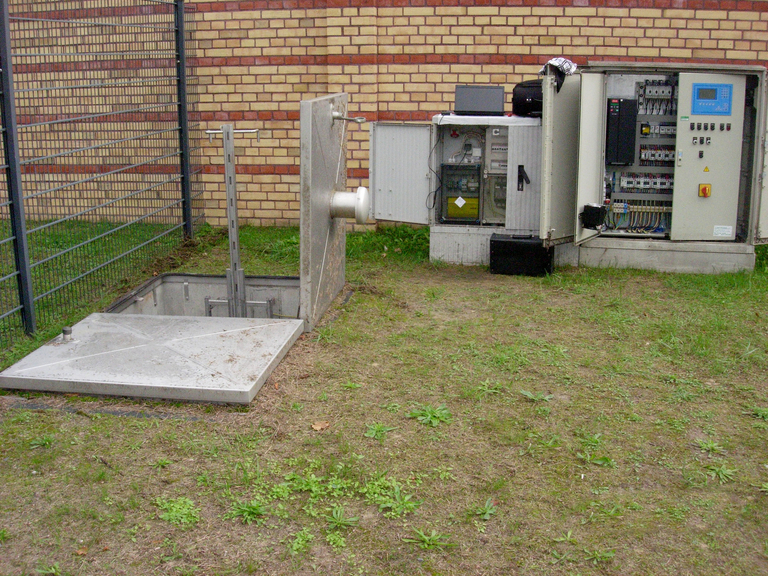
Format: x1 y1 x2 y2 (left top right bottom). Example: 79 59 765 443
188 0 768 230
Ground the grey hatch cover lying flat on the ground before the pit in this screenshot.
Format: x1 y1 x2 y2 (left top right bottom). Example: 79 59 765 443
0 314 304 404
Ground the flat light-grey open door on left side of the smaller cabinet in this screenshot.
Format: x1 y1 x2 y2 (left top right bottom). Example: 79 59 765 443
369 122 434 224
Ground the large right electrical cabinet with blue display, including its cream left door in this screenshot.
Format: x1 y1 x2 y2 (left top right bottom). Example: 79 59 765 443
575 63 765 258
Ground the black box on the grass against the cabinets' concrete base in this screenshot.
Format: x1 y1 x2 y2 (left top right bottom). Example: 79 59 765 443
490 234 554 276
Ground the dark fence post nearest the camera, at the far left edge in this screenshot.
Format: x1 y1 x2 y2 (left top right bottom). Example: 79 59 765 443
0 2 37 334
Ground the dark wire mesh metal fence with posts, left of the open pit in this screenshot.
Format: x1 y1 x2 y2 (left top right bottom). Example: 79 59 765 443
0 0 202 345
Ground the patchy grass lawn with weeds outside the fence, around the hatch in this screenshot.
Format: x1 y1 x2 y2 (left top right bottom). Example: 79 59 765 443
0 228 768 576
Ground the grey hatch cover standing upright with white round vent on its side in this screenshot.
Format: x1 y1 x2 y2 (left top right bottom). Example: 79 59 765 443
299 94 348 331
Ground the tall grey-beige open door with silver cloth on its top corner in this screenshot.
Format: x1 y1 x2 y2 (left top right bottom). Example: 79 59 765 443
539 74 581 247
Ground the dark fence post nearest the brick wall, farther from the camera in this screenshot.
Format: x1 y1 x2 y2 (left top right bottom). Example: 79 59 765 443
176 0 194 238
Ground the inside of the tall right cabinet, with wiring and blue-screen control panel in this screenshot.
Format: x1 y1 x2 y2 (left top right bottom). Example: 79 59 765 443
602 72 745 240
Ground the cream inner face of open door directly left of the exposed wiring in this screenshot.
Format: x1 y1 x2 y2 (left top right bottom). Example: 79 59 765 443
574 72 606 244
